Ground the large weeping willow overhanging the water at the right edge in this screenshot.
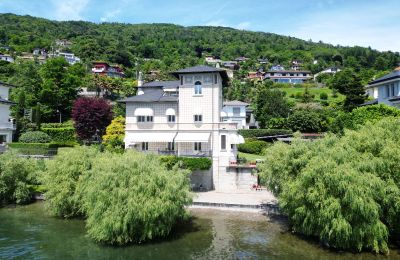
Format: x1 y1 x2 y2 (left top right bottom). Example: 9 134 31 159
260 118 400 253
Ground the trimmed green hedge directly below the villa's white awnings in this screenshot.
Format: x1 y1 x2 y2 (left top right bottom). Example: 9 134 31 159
160 155 212 171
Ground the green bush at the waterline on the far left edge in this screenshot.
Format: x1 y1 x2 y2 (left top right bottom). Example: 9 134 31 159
0 152 39 206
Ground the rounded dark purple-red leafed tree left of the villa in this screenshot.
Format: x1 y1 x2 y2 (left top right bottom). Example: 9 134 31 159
72 98 112 140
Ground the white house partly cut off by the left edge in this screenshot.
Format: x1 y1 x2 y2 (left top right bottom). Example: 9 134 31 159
0 82 15 143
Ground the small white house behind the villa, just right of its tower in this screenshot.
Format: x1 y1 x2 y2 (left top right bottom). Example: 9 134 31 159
221 100 249 129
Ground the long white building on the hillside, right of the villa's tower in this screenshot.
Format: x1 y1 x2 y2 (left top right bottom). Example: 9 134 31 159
264 70 312 84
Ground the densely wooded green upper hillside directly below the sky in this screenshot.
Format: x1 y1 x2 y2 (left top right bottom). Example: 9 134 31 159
0 14 400 73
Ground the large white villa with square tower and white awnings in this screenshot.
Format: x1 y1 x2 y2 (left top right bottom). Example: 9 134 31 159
121 66 245 190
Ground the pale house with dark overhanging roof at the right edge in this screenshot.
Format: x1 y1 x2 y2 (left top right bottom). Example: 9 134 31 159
364 67 400 108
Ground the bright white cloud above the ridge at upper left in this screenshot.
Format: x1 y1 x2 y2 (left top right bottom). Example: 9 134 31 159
52 0 89 21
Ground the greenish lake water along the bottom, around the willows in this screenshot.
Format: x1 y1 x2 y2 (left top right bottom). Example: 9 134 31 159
0 202 400 260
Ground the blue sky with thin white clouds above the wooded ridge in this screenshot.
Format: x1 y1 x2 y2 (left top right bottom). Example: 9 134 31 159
0 0 400 51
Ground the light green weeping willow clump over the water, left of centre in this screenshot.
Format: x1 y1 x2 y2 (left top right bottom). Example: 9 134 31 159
46 148 191 245
